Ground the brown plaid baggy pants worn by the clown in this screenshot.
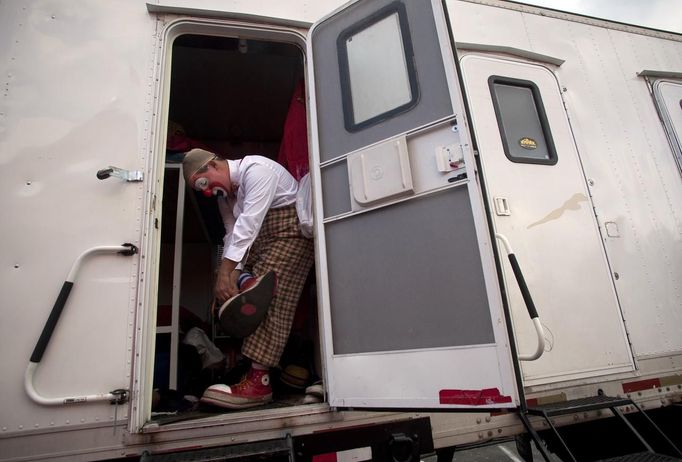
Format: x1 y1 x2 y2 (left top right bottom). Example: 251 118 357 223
242 205 315 367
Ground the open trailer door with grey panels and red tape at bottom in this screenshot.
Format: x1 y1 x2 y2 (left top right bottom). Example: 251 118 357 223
308 0 516 409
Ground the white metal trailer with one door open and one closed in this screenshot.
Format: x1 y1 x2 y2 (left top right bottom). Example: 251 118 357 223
0 0 682 461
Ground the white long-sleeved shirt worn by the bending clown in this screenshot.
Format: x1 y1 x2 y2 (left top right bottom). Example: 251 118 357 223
218 156 298 262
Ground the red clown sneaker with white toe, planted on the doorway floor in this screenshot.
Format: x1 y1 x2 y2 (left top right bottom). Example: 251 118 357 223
201 367 272 409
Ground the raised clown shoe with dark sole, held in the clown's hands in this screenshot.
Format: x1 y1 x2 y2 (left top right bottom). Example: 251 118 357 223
218 271 277 338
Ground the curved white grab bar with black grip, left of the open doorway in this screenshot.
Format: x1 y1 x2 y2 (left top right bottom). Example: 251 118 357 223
24 243 137 406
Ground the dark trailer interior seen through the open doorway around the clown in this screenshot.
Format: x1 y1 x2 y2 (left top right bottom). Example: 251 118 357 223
152 35 319 423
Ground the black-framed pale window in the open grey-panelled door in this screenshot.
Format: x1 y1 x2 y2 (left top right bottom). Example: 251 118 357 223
337 2 418 131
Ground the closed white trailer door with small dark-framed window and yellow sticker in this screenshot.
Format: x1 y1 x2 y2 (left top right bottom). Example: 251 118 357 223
461 55 633 385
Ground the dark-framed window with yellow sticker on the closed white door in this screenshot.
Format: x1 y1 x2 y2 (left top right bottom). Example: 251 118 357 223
488 76 558 165
